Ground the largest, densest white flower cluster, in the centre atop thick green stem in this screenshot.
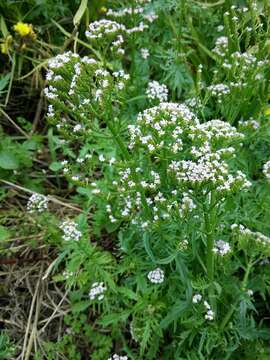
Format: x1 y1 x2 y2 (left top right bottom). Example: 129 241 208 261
107 103 251 229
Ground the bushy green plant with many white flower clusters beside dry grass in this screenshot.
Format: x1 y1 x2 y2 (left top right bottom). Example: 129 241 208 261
11 0 270 360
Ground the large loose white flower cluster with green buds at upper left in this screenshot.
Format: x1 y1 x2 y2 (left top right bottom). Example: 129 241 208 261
44 52 129 129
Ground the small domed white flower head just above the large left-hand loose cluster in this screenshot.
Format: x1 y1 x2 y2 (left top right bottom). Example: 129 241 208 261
85 19 126 39
